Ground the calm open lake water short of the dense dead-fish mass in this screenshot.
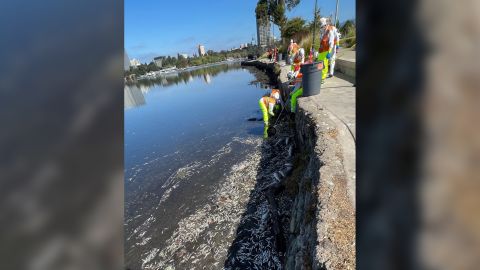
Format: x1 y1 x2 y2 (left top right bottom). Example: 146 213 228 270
124 63 267 269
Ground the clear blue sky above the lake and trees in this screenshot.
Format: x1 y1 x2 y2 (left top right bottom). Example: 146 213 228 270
124 0 355 63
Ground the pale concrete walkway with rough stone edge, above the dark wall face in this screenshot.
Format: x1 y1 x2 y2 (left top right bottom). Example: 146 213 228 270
295 70 356 270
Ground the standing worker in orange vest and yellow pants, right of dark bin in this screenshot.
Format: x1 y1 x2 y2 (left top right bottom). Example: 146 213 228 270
317 18 338 83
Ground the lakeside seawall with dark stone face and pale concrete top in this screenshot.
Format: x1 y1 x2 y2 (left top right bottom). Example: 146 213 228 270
242 60 355 269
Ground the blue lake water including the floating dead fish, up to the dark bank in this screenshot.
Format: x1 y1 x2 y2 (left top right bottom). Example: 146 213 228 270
124 63 268 269
